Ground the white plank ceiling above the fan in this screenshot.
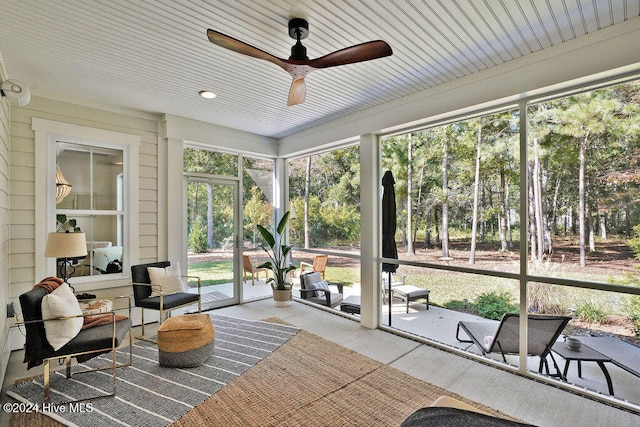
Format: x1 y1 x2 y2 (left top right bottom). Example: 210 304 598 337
0 0 640 138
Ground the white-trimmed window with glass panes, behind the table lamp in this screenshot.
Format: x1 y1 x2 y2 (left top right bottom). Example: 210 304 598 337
32 119 140 290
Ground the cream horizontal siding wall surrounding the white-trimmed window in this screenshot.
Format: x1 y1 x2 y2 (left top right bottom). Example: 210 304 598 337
10 97 159 297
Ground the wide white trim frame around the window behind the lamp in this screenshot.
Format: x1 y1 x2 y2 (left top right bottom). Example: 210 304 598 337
32 118 141 291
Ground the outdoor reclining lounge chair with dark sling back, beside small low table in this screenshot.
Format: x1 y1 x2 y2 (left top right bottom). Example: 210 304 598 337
456 313 571 377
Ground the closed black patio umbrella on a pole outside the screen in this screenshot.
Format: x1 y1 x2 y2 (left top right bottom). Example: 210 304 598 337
382 171 398 326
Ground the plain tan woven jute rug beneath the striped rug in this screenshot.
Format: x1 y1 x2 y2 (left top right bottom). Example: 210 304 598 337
12 319 513 427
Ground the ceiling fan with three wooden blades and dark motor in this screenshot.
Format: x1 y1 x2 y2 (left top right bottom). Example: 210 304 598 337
207 18 393 106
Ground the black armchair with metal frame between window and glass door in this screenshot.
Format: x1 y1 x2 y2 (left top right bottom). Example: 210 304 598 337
131 261 202 343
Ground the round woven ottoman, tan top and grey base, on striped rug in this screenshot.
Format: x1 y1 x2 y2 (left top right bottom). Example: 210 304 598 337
158 314 215 368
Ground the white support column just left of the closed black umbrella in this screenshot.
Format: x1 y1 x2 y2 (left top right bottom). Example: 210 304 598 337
360 134 381 329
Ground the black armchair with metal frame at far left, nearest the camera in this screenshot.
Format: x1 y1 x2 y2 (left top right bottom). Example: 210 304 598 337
17 287 132 403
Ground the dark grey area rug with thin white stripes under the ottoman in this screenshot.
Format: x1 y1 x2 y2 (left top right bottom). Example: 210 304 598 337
7 314 299 427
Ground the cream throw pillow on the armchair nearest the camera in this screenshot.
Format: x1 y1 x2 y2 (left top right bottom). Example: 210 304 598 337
42 283 84 350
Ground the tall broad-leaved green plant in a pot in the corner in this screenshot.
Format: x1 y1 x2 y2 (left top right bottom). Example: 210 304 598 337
256 211 295 307
